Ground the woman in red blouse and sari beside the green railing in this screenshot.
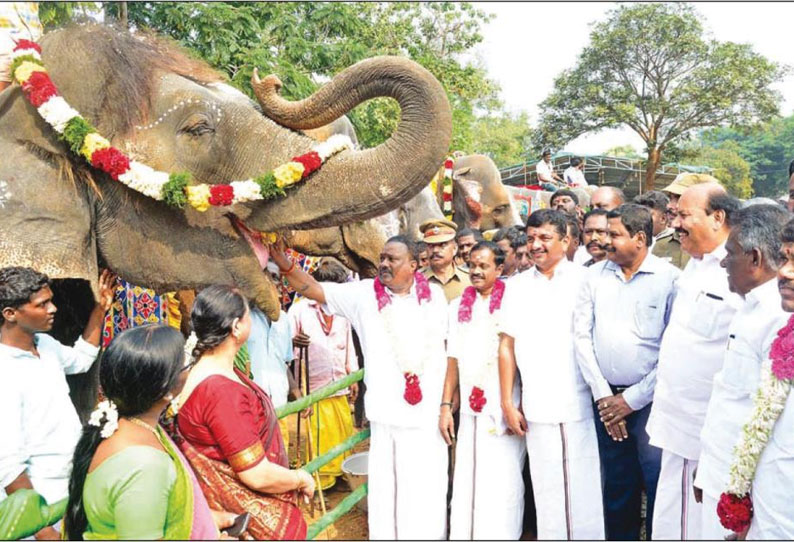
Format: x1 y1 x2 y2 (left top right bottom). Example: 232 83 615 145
171 286 314 540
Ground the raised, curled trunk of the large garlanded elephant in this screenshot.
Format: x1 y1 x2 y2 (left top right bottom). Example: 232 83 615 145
252 57 452 229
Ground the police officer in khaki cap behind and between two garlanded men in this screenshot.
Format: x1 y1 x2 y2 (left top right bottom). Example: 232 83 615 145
419 219 471 302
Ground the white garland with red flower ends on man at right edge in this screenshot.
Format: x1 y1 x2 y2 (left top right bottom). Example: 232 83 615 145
717 315 794 533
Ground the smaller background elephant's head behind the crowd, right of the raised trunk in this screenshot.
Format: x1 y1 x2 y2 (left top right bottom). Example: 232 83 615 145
452 154 521 231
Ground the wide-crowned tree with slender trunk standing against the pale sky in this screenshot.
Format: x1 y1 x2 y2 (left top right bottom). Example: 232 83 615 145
538 3 786 190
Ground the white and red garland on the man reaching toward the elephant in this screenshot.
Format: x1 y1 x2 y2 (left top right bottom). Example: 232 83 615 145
374 272 431 405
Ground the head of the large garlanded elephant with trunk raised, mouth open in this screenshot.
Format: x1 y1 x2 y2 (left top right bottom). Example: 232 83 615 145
0 25 451 319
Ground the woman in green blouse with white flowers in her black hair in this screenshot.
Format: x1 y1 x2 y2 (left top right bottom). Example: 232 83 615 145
64 325 229 540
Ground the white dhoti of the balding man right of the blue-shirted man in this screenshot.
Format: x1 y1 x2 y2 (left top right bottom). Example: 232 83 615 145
653 450 700 540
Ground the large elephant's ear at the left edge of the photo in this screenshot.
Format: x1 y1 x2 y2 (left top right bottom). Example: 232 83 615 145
0 85 98 291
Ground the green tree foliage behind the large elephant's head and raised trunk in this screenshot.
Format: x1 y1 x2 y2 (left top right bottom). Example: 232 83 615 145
45 2 501 154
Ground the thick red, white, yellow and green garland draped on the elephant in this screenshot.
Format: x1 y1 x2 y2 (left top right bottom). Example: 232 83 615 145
10 40 353 212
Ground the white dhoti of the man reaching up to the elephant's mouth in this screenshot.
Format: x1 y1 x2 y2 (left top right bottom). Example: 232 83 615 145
367 422 448 540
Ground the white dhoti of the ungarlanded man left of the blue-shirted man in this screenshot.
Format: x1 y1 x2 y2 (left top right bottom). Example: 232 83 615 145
526 418 604 540
